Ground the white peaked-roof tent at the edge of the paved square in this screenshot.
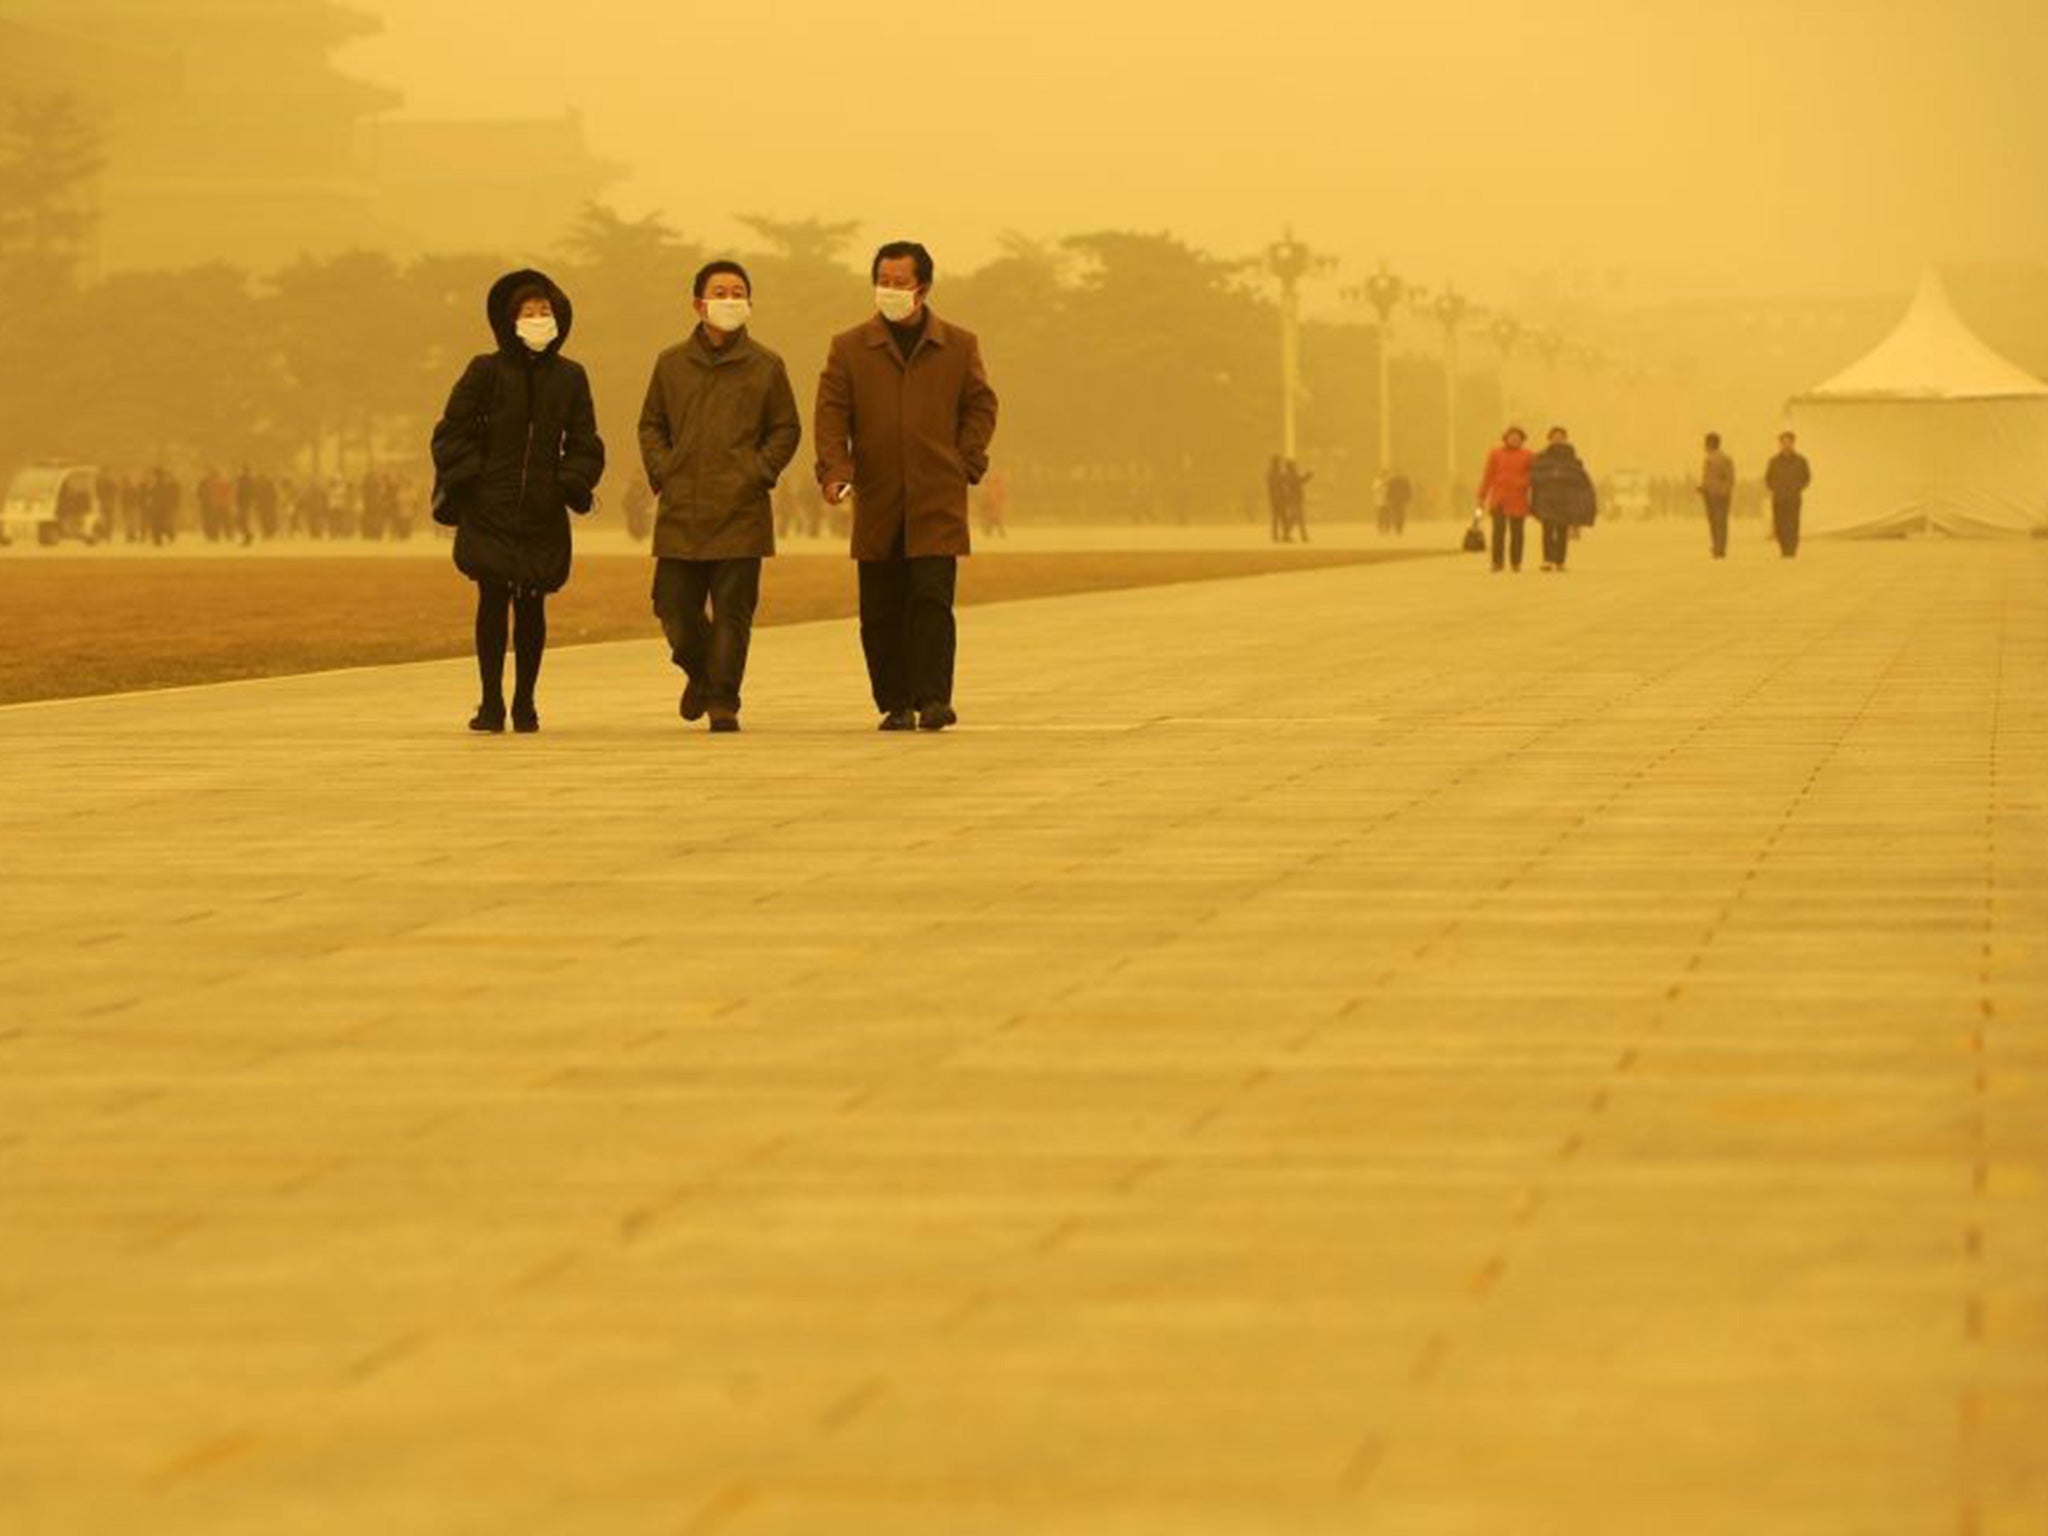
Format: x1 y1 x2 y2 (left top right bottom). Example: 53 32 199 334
1792 272 2048 537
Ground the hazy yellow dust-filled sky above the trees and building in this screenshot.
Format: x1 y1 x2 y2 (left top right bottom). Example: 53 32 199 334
346 0 2048 303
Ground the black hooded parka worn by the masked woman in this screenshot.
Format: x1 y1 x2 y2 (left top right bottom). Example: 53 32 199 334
434 270 604 592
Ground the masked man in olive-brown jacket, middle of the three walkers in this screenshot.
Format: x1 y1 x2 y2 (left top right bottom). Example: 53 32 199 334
639 262 803 731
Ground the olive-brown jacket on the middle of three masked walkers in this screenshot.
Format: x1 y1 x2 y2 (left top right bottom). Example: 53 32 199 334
639 330 803 559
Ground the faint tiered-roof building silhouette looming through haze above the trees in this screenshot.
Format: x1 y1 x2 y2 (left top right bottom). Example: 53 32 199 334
0 0 618 270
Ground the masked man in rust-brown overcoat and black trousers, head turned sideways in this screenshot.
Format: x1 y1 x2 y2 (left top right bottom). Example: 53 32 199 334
817 240 995 731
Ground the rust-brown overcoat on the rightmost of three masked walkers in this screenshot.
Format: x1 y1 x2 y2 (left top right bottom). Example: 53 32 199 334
815 315 995 561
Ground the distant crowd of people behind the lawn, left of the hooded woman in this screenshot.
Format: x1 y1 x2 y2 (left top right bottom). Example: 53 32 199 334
81 465 422 547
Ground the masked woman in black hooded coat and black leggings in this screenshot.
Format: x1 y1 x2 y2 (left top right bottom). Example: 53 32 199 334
434 270 604 731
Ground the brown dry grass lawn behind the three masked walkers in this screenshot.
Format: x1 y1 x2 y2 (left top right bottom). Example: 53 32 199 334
0 549 1441 705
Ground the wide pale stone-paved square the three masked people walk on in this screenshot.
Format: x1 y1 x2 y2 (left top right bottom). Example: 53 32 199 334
0 530 2048 1536
